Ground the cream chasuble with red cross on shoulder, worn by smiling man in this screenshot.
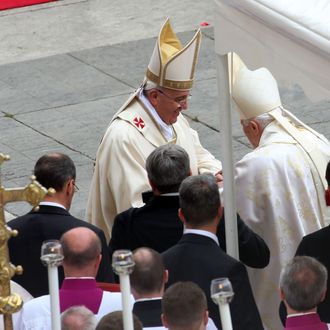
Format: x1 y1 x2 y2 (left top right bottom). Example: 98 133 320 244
86 94 222 239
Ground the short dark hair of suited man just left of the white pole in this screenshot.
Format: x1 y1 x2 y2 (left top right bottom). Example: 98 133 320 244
179 174 221 227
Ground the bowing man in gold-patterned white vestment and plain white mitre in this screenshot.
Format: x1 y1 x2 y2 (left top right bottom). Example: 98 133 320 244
232 55 330 330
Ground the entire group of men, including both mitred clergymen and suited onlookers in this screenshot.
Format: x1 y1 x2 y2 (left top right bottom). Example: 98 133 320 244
4 20 330 330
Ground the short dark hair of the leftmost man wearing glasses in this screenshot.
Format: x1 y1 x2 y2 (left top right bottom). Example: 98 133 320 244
34 152 76 191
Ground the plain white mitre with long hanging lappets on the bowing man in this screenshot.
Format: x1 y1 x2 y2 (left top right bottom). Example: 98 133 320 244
229 53 329 189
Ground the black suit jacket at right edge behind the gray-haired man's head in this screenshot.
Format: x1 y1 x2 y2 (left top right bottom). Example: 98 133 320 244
280 226 330 324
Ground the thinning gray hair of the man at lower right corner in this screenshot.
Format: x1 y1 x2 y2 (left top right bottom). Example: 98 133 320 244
280 256 328 312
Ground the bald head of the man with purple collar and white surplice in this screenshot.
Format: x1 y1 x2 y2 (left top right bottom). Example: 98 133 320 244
61 227 102 268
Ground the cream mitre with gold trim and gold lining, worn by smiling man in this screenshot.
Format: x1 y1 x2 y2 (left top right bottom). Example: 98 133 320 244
146 19 202 90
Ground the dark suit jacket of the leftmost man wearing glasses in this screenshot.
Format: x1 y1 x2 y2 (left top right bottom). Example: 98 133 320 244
8 205 114 297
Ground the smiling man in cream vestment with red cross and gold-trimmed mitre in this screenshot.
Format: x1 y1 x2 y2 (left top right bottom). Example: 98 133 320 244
86 20 222 237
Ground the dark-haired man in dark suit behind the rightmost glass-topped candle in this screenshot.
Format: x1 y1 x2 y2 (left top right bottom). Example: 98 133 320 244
162 174 263 330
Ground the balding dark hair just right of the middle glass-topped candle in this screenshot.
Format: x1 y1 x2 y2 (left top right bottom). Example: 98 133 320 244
130 248 165 294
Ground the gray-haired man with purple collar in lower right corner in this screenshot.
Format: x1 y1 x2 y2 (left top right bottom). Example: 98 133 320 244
280 256 330 330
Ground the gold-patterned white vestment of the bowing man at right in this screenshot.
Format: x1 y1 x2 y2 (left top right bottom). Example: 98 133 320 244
235 122 330 330
